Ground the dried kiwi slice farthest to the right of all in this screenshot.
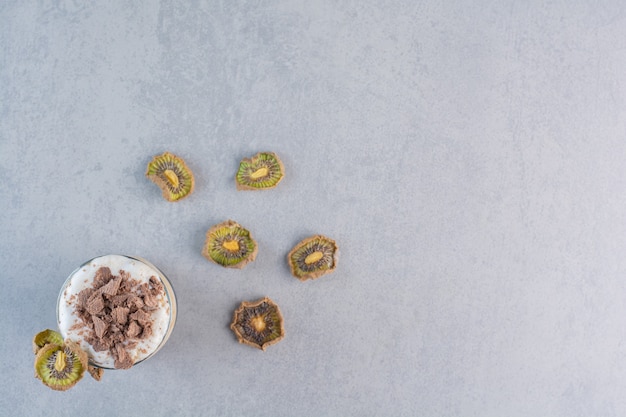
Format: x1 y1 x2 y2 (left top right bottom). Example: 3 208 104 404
287 235 338 281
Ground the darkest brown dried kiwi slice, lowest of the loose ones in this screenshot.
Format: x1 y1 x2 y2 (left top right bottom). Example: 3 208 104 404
230 297 285 350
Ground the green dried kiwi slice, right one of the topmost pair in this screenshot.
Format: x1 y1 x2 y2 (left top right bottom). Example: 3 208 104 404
235 152 285 190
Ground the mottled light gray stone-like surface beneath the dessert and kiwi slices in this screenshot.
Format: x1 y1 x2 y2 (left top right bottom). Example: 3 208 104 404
0 0 626 417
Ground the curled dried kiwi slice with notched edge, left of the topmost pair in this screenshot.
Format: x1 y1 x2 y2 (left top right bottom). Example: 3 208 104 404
146 152 194 201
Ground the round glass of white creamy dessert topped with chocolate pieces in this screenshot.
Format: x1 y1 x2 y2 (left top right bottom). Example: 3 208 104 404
57 255 176 369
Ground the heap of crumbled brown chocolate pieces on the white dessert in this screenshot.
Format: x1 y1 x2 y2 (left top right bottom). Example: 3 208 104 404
76 267 164 369
